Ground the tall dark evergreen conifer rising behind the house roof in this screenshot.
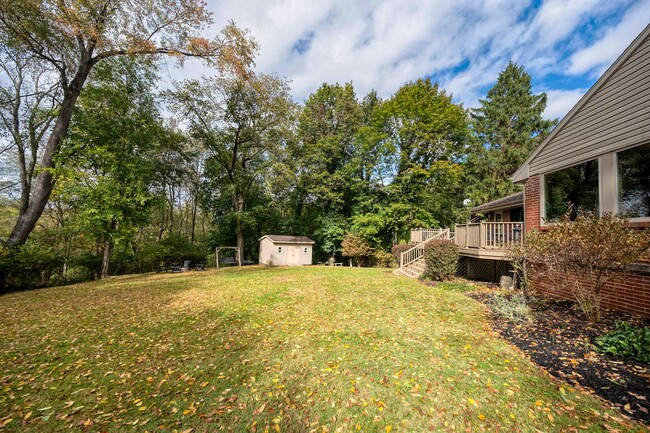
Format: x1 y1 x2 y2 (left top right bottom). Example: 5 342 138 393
468 62 557 204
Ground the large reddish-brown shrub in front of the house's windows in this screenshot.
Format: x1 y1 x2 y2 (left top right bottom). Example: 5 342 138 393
524 211 650 321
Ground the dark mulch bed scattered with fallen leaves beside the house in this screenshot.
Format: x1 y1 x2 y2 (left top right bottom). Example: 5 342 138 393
468 292 650 425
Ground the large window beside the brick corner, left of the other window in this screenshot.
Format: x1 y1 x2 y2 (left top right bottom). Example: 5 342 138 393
544 159 599 221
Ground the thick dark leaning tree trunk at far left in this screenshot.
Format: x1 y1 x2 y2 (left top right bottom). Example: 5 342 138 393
7 58 93 246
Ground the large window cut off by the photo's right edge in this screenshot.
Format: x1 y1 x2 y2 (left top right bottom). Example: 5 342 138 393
617 144 650 218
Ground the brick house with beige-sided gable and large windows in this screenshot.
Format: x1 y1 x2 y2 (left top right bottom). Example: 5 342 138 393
513 25 650 316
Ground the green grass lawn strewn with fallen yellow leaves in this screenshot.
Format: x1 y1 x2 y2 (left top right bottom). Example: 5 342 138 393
0 267 646 432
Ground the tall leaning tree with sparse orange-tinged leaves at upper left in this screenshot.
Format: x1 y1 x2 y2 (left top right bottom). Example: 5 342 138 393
0 0 255 245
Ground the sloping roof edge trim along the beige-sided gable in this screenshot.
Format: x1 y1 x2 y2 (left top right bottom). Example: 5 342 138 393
511 24 650 183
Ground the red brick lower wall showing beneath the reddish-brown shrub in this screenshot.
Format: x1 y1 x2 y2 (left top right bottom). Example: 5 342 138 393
531 272 650 317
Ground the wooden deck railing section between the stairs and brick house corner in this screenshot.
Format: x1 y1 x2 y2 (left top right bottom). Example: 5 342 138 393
455 222 524 249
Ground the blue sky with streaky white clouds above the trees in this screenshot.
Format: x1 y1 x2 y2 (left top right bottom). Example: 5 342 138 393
189 0 650 118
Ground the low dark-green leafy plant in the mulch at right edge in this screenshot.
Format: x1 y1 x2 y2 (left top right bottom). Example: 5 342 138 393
595 320 650 364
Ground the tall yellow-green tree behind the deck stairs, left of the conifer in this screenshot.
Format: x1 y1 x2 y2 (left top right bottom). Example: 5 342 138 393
377 79 468 233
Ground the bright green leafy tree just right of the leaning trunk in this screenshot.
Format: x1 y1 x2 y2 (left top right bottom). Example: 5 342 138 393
55 58 161 278
